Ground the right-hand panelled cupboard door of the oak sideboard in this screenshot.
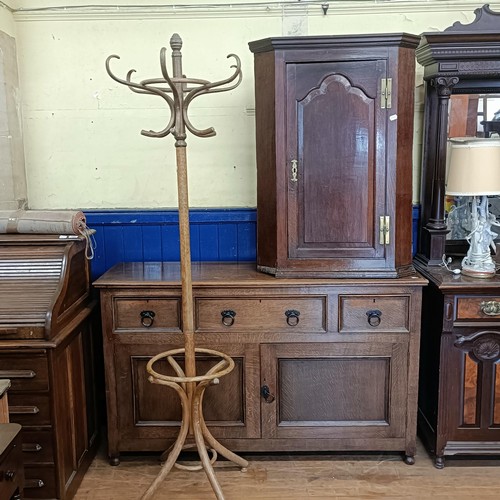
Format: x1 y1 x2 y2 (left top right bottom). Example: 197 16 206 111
261 339 408 440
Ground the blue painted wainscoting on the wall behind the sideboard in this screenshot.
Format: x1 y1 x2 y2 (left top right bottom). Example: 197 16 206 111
85 207 419 280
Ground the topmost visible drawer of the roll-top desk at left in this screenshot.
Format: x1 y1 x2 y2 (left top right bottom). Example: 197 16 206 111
0 350 49 392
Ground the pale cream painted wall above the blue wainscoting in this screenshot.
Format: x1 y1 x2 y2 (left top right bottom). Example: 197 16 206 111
4 0 492 209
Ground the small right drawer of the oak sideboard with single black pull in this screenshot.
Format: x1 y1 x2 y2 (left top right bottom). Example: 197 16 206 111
339 295 410 333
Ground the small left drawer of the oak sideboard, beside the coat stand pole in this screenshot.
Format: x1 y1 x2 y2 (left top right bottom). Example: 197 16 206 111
113 297 181 333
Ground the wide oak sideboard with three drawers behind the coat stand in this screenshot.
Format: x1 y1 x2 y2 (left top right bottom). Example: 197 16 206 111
95 262 426 464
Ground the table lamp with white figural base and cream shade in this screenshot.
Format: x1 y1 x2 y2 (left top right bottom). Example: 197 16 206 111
446 137 500 278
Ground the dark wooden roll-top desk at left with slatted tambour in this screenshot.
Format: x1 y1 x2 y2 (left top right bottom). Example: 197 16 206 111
0 234 99 500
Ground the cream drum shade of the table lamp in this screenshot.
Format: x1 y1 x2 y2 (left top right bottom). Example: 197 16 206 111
446 137 500 196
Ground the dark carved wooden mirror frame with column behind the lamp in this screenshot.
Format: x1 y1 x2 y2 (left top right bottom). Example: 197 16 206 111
415 4 500 266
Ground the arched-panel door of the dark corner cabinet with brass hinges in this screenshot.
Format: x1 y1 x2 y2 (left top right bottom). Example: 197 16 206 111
286 59 393 270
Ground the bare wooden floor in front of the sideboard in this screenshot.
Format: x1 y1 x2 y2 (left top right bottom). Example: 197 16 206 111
75 440 500 500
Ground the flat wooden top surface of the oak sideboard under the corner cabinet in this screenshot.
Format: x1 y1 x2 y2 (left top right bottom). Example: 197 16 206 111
94 262 427 288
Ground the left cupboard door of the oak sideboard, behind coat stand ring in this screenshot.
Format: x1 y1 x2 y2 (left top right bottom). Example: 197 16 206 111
115 344 260 451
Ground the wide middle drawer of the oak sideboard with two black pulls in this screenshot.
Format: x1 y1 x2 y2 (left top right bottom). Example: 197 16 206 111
195 296 327 333
